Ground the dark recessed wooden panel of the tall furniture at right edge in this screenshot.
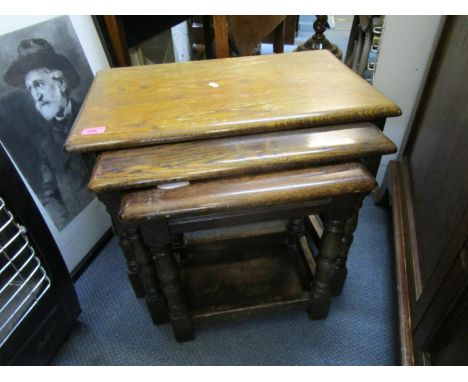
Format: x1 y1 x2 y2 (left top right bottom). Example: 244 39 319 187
406 17 468 284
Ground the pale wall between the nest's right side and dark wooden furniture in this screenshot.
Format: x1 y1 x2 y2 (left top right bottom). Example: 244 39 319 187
373 16 444 182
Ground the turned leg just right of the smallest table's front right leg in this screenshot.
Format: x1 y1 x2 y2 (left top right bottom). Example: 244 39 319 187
332 200 362 296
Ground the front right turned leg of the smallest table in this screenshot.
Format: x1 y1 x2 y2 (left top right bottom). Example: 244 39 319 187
309 200 353 319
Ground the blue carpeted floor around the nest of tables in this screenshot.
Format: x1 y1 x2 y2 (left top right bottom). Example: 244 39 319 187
52 198 399 365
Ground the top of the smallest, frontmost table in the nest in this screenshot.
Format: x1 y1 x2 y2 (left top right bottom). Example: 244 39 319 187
120 163 376 222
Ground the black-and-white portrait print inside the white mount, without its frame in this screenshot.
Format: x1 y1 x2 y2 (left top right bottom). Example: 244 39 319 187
0 16 94 231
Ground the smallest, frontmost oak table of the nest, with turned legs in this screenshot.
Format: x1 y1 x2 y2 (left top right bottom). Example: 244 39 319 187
120 163 376 341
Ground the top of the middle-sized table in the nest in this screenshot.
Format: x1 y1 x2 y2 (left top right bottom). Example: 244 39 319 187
89 122 396 192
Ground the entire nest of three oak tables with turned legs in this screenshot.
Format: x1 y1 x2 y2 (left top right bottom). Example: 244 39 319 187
65 51 400 340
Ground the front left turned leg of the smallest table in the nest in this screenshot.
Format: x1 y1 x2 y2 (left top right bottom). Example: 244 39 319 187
141 221 195 342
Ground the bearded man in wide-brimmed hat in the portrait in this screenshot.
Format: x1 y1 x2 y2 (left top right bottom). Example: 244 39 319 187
3 38 92 230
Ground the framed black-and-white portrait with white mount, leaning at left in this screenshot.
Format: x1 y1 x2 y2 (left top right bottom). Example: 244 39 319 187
0 16 111 272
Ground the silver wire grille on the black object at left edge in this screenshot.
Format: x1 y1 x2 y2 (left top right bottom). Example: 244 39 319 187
0 197 51 348
